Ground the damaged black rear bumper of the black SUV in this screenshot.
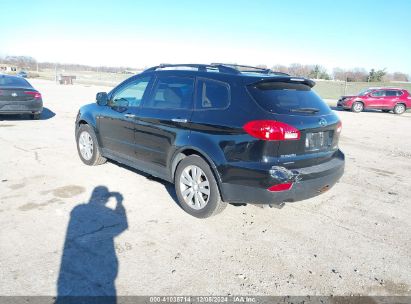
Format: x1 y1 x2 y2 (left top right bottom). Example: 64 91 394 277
221 151 345 205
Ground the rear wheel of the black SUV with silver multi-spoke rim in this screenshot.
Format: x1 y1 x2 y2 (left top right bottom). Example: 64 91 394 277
174 155 227 218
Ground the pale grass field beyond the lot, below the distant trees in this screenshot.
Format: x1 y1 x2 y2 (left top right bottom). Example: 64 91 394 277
32 70 411 99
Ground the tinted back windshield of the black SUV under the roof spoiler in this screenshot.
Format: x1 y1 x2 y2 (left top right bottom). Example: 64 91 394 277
248 82 331 114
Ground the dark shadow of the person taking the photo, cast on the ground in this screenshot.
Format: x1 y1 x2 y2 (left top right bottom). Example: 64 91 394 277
56 186 128 304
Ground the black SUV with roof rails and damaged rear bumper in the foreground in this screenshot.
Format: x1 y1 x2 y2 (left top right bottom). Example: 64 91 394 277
75 64 344 217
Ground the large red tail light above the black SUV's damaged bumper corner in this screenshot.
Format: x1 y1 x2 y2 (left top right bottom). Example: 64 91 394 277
243 120 301 140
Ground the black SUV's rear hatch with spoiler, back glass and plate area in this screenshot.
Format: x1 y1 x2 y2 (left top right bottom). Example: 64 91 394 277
247 77 341 168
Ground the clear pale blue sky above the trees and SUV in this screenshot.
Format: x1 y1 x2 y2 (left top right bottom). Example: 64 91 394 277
0 0 411 74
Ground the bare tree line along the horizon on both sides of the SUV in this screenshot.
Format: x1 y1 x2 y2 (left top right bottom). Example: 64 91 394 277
0 56 411 82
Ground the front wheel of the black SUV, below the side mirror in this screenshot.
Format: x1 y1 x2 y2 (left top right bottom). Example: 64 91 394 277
76 124 107 166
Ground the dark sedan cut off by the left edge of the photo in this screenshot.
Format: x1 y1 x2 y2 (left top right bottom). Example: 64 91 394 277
0 74 43 119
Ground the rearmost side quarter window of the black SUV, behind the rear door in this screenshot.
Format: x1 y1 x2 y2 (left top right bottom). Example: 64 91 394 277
196 78 230 110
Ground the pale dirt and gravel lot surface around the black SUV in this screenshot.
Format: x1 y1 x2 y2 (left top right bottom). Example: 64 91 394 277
0 80 411 295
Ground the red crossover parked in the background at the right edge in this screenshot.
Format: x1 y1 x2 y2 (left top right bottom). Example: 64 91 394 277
337 88 411 114
